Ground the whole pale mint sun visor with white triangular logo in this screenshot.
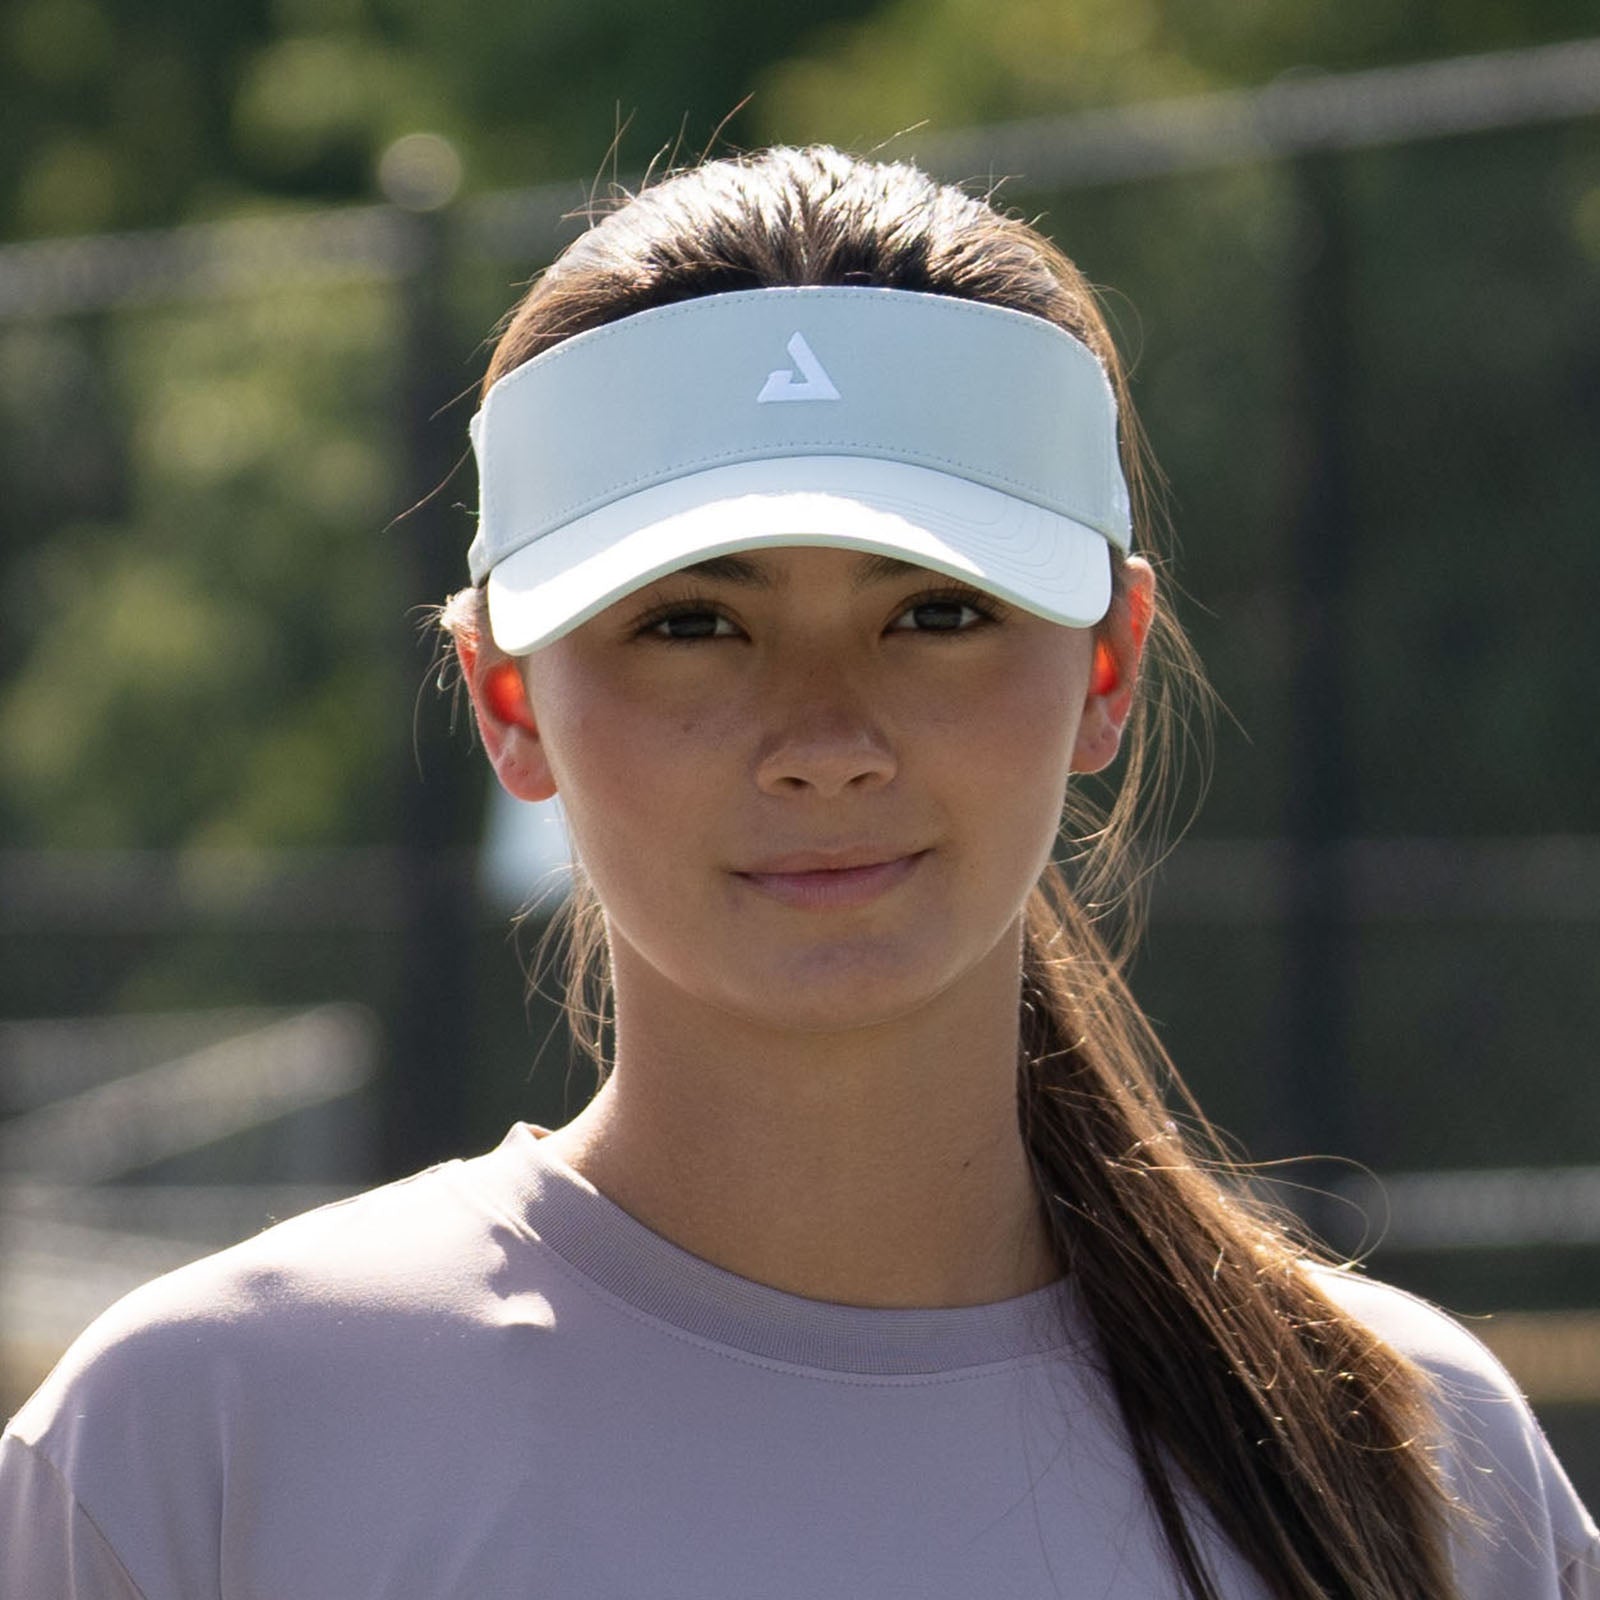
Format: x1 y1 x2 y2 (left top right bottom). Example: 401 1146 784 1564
469 288 1131 654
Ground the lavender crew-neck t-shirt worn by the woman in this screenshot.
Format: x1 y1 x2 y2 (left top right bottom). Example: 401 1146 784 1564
0 1126 1600 1600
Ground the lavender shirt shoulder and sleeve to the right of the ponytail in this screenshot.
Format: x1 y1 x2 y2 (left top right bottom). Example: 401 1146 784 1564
1314 1269 1600 1600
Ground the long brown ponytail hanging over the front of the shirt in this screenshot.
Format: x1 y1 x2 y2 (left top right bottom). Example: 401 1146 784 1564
1018 867 1454 1600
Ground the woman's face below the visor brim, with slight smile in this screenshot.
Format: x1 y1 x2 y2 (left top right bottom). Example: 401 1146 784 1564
518 547 1120 1032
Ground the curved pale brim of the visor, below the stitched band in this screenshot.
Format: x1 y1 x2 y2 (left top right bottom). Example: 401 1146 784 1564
488 456 1110 656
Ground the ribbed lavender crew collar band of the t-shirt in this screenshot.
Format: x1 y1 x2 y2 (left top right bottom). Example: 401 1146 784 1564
490 1123 1082 1378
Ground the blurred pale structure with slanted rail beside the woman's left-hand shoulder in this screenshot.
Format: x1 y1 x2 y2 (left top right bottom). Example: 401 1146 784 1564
0 1005 378 1400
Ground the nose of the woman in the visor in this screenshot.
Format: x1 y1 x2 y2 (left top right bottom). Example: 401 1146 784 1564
755 667 896 797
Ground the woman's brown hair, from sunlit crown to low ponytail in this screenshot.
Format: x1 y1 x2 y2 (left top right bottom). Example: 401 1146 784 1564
445 149 1456 1600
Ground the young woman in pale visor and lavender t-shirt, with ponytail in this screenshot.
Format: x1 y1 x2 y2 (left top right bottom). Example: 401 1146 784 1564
0 150 1600 1600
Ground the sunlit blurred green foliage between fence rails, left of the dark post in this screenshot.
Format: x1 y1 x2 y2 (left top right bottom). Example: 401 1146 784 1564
0 290 406 846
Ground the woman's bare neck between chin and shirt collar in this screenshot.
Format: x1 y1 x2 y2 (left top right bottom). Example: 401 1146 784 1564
550 941 1059 1306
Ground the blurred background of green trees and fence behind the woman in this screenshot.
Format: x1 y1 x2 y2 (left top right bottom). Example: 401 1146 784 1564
0 0 1600 1504
